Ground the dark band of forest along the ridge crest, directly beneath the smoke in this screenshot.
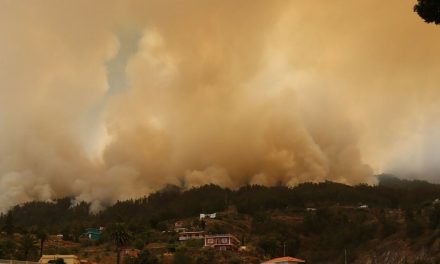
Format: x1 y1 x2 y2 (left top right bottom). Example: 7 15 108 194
0 175 440 233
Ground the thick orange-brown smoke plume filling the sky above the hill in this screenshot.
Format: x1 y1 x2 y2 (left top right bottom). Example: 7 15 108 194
0 0 440 210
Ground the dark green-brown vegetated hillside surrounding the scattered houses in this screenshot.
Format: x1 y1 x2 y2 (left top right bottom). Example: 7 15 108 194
0 175 440 263
